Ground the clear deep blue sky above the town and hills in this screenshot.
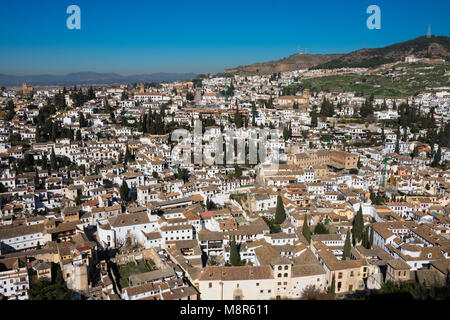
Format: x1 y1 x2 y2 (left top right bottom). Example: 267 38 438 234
0 0 450 75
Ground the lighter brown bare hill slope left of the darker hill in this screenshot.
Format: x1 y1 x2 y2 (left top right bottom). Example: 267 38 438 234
223 54 341 75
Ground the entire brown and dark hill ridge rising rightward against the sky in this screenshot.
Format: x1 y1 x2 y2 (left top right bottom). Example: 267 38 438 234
221 36 450 75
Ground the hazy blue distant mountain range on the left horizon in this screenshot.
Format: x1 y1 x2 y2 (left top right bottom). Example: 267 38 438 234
0 72 197 87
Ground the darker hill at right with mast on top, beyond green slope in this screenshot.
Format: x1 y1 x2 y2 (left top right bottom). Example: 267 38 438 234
312 36 450 69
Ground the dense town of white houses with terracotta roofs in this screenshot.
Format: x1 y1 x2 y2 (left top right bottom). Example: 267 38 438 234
0 69 450 300
